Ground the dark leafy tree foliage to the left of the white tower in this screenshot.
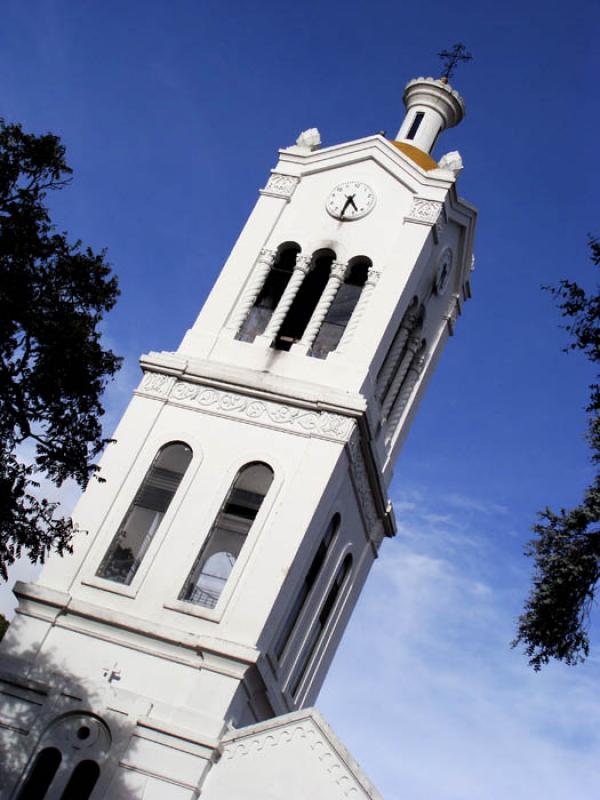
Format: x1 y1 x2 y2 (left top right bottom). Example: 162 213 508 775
0 119 120 578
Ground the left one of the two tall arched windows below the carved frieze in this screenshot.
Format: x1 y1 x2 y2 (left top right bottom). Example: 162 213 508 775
96 442 192 585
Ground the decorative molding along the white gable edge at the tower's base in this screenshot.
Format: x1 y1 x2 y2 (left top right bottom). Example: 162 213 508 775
223 721 367 798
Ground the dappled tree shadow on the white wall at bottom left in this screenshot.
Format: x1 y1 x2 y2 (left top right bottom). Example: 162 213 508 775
0 640 146 800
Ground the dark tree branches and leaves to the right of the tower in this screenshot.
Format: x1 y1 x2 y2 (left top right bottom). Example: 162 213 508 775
513 238 600 670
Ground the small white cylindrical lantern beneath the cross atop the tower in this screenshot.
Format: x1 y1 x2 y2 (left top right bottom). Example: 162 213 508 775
396 78 465 158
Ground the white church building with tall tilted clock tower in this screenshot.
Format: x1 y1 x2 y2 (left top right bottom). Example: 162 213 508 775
0 72 476 800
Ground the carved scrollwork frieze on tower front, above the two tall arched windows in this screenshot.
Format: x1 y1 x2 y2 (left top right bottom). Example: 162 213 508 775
138 372 354 442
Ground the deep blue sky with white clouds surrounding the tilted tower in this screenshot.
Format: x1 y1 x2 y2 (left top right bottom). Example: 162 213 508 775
0 0 600 800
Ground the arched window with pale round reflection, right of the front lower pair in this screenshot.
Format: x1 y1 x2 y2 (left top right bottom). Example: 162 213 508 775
179 462 273 608
